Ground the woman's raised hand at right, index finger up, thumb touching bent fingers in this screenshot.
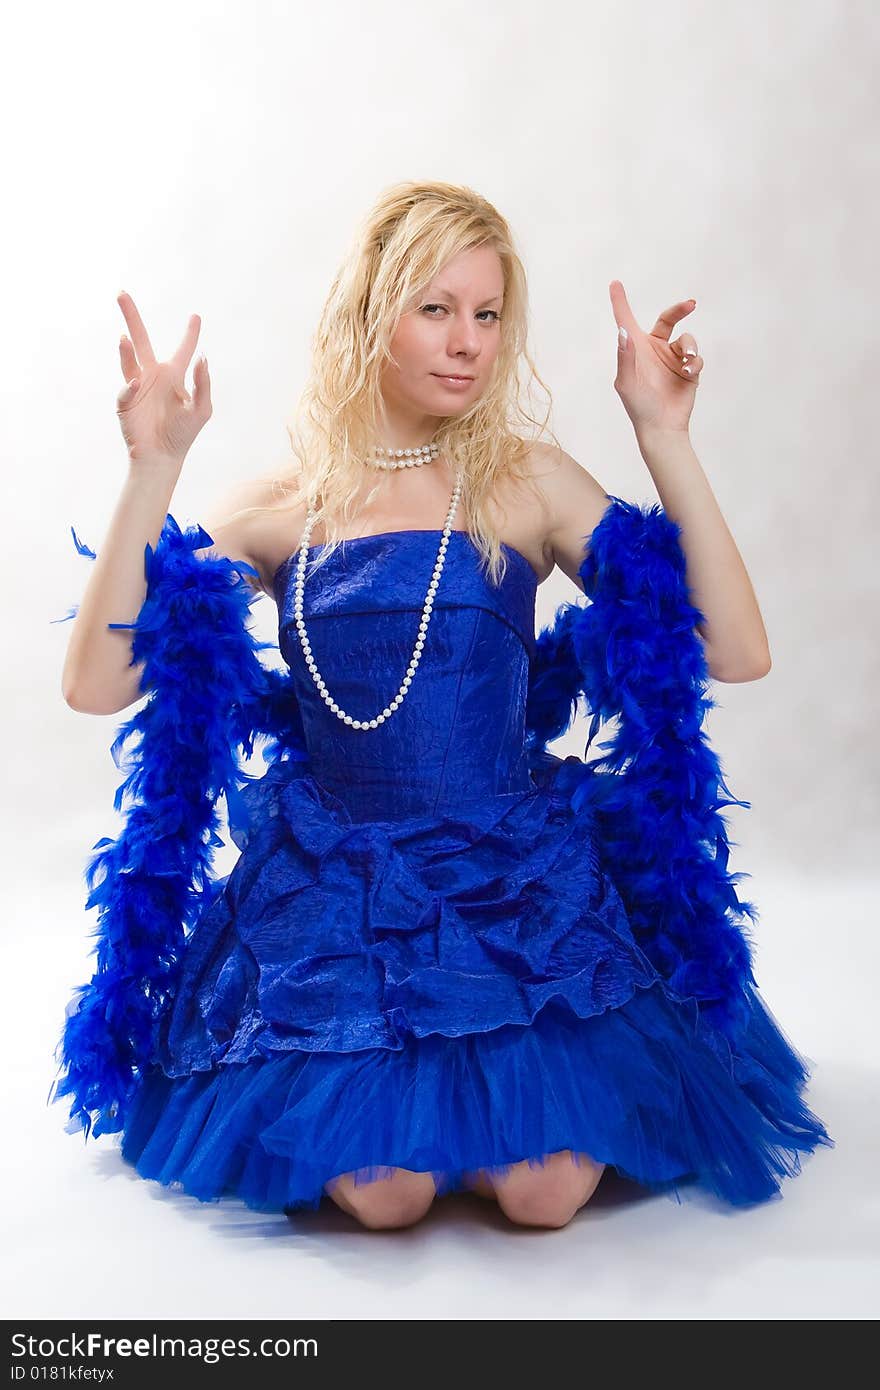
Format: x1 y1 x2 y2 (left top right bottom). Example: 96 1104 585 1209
609 279 703 431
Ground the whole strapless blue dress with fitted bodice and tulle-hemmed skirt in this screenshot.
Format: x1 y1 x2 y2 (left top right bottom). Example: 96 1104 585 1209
113 531 831 1211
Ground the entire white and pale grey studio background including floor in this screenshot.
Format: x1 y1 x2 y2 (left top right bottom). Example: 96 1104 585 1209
0 0 880 1319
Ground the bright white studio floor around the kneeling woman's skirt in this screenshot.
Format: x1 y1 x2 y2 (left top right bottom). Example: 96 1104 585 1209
0 863 880 1321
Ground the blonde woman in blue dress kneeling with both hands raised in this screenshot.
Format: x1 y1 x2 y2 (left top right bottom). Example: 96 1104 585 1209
57 183 831 1227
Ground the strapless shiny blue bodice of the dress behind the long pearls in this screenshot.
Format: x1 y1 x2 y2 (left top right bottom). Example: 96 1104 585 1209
272 530 538 820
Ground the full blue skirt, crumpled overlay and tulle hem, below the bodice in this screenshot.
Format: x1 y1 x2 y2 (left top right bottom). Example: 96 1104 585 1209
122 760 831 1211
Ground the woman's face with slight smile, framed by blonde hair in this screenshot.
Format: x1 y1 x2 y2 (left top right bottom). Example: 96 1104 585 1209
382 246 505 420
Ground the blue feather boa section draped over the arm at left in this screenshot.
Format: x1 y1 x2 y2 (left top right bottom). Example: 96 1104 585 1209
50 516 306 1137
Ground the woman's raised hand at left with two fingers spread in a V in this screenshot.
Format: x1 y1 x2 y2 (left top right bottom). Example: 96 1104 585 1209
117 291 211 467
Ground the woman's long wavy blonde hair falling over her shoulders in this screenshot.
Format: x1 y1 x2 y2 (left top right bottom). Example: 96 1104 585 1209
236 181 557 584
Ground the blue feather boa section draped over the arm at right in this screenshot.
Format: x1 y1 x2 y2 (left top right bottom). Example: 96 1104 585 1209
527 495 758 1051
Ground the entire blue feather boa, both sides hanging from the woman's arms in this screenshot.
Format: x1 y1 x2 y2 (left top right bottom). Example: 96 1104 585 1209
50 495 755 1137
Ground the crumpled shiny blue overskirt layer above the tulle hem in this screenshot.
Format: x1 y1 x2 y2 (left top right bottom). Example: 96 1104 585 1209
152 762 655 1076
